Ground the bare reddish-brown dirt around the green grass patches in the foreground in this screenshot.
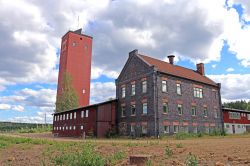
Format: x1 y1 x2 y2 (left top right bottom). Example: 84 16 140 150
0 133 250 166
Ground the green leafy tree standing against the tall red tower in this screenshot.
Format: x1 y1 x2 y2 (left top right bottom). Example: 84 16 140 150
55 72 79 112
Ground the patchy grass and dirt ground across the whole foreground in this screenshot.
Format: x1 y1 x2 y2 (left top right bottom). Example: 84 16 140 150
0 133 250 166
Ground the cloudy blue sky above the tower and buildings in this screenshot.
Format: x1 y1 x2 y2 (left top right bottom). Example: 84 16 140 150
0 0 250 123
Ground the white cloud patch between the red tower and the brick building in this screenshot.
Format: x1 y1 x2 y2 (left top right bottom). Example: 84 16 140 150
90 82 116 104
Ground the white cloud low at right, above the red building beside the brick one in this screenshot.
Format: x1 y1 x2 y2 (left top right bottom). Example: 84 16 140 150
208 74 250 101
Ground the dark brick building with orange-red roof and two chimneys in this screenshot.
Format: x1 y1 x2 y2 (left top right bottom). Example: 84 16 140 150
116 50 223 136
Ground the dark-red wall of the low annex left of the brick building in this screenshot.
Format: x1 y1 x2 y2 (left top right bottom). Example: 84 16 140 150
53 100 117 137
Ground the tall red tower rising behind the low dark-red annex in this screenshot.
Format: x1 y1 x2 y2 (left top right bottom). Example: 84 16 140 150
57 29 92 106
